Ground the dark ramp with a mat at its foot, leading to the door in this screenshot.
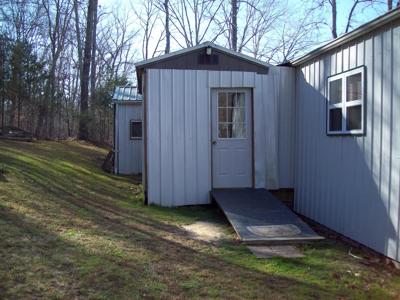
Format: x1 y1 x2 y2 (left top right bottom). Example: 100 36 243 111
211 189 323 245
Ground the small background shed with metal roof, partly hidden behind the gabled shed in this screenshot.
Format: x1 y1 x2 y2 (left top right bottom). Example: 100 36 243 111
112 86 143 175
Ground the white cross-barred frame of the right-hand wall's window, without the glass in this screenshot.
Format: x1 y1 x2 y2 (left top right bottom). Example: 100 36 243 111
326 66 365 135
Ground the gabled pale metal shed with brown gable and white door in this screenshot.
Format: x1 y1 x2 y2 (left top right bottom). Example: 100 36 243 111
136 42 294 206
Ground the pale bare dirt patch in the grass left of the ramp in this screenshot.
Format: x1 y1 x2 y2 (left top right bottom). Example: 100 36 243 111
182 221 227 242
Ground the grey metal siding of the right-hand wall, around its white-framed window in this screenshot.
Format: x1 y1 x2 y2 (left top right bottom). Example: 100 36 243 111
294 25 400 260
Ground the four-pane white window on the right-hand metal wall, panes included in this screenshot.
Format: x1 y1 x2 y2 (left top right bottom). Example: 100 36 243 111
327 67 365 135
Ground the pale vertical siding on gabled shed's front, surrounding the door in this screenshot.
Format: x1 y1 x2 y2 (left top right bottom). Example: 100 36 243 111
145 68 294 206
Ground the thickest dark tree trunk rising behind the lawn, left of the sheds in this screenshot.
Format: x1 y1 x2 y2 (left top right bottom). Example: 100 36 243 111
78 0 97 140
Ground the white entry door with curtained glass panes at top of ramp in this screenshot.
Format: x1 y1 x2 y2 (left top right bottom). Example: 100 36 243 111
211 89 253 188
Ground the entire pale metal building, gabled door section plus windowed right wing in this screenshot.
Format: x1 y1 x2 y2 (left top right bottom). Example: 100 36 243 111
116 9 400 260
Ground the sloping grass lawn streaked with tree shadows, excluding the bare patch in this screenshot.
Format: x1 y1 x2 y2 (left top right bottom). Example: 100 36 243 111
0 141 400 299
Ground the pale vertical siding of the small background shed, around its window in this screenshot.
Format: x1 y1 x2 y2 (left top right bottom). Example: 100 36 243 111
115 103 143 174
